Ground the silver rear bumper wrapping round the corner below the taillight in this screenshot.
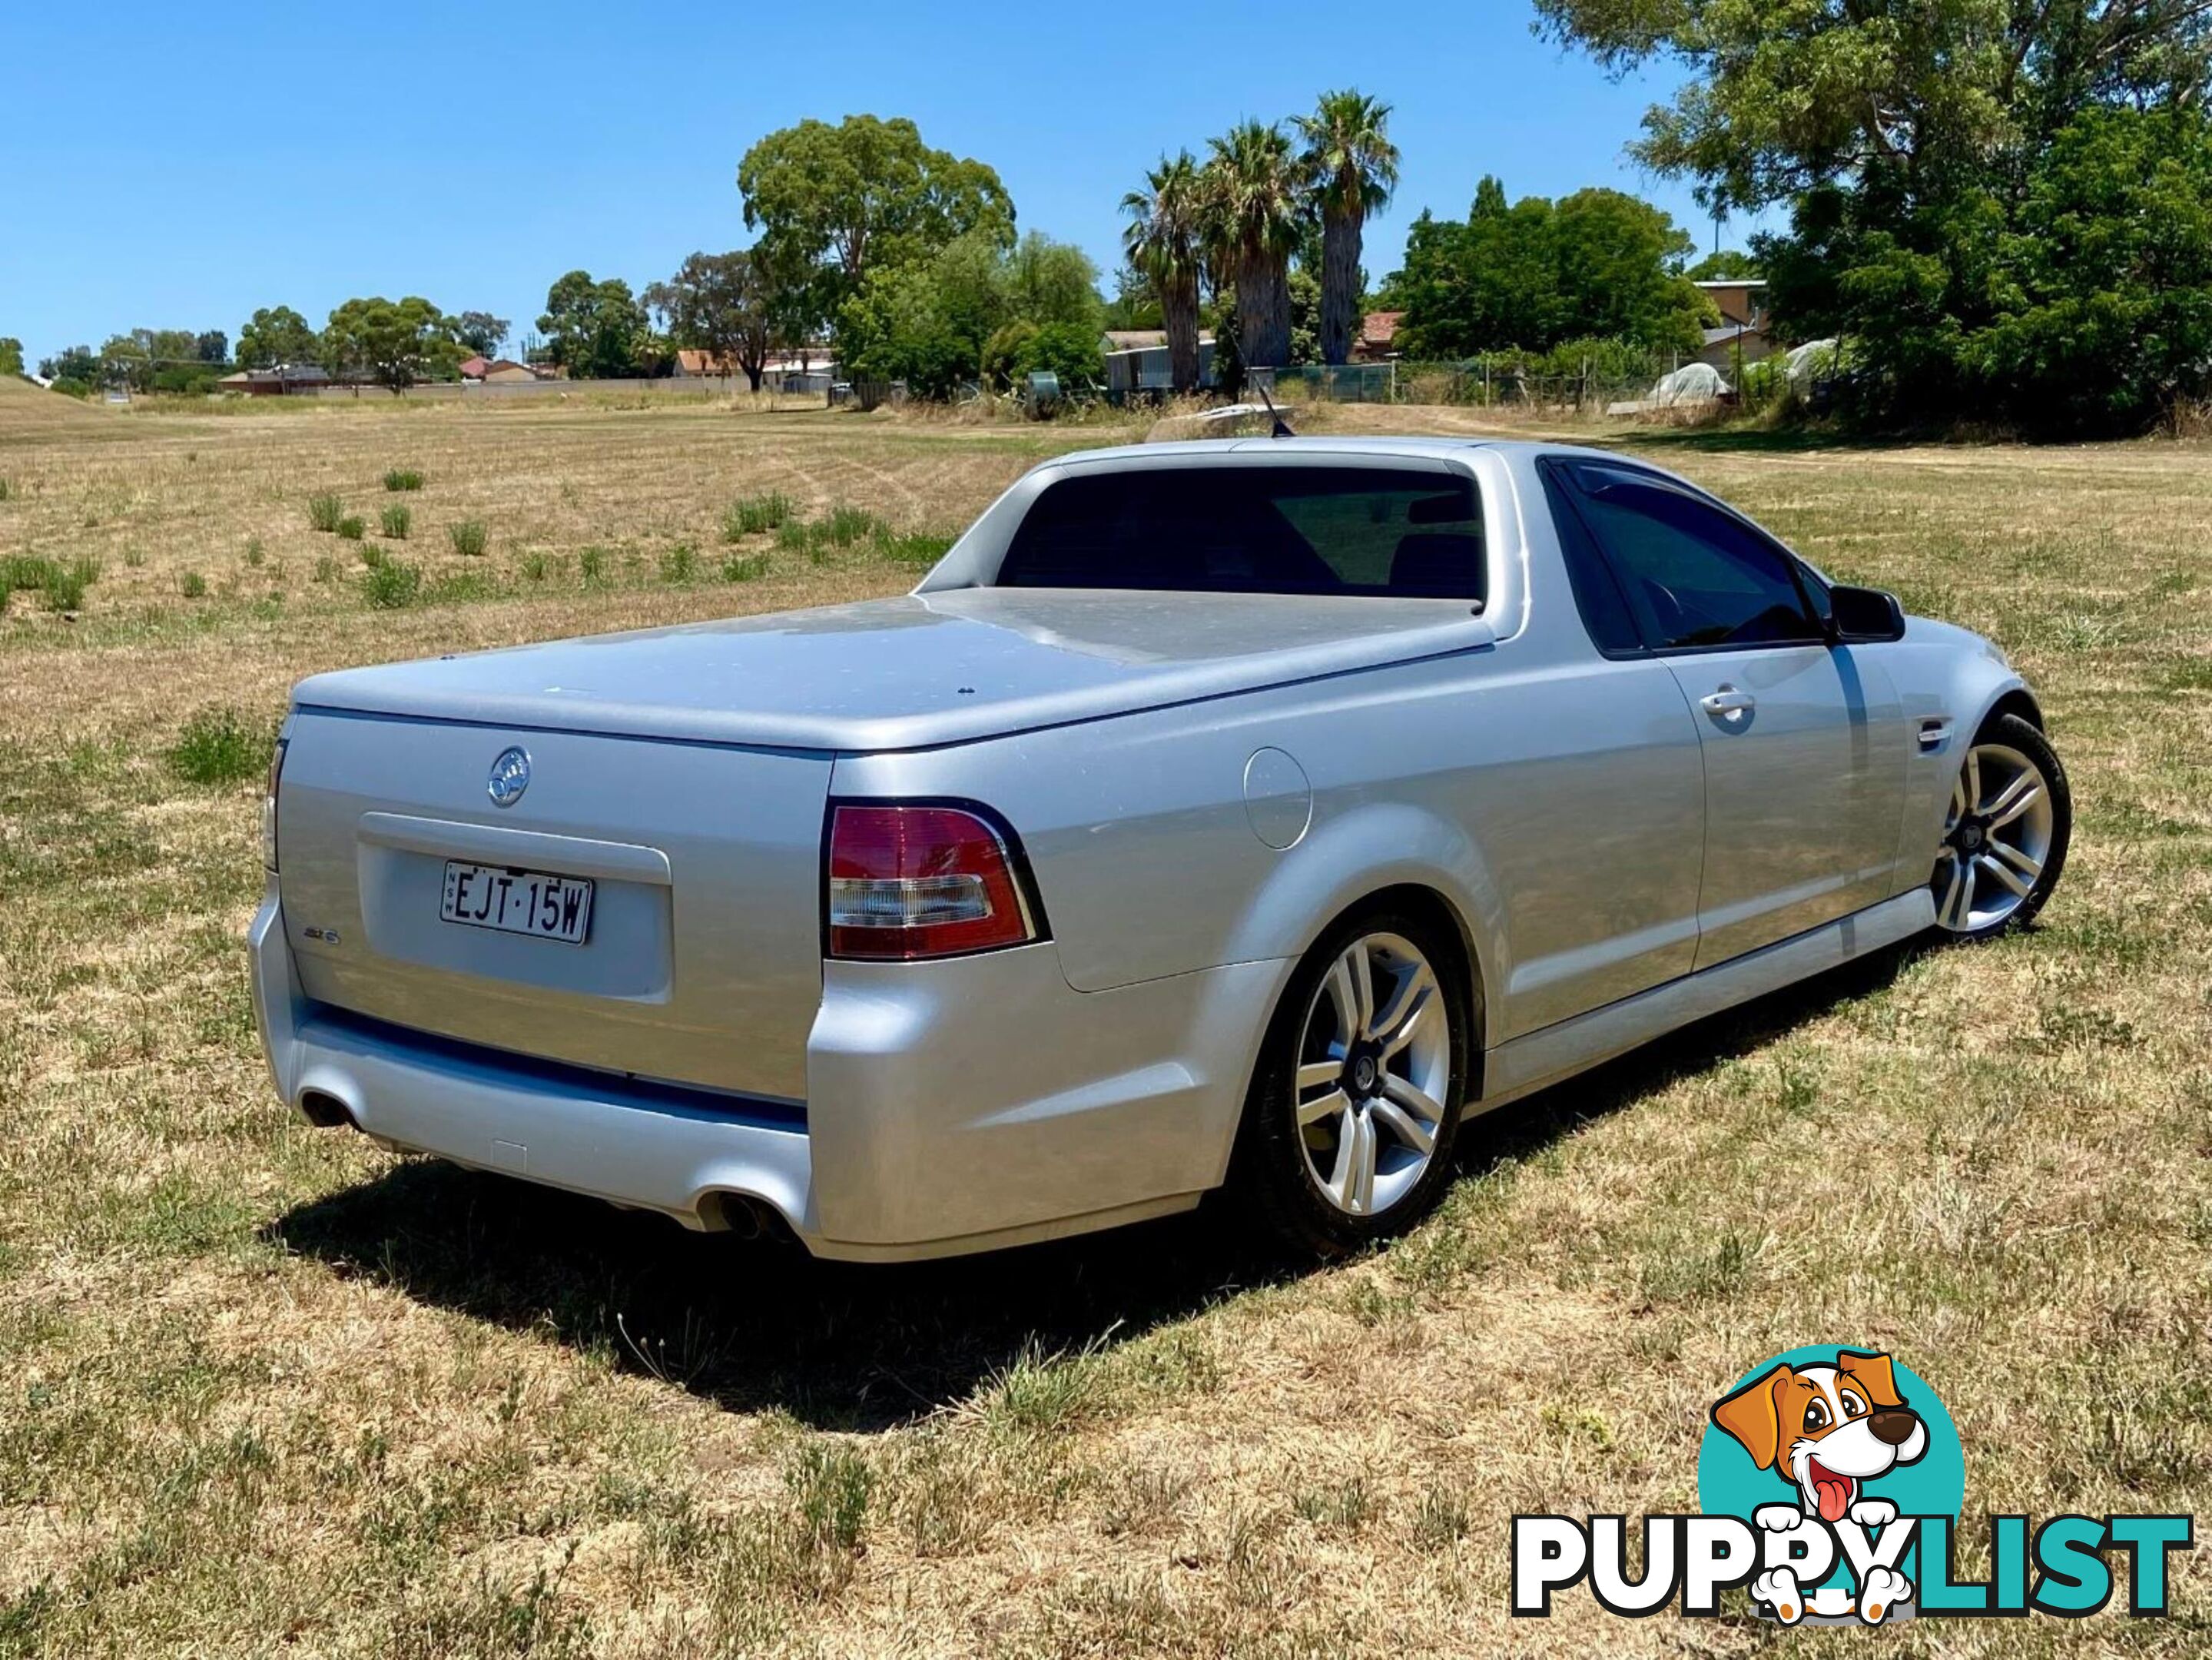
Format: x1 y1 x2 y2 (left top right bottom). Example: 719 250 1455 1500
247 888 1288 1260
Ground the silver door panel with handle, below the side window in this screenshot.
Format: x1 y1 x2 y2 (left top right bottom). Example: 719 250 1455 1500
1670 646 1905 969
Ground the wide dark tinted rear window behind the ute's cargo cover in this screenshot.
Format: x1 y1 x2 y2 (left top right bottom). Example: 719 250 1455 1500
997 467 1489 604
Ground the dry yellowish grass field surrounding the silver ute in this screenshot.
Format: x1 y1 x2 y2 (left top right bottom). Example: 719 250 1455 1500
0 385 2212 1655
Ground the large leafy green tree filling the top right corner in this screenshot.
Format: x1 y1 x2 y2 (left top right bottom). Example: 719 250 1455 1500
1537 0 2212 430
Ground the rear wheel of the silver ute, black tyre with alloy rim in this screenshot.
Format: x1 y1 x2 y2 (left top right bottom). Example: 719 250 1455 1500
1230 910 1473 1260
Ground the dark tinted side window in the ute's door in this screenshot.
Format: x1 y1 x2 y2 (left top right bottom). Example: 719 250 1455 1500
1575 467 1822 651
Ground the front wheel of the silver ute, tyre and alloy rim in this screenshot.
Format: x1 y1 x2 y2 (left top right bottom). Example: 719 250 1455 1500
1928 715 2073 943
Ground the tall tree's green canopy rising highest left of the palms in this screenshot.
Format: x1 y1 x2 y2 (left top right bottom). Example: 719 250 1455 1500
737 115 1013 334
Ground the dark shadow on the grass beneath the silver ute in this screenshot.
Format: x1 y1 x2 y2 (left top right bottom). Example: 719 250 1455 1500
264 948 1913 1432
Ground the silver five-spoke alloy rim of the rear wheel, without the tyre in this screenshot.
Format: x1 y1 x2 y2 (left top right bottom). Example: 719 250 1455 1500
1292 934 1451 1215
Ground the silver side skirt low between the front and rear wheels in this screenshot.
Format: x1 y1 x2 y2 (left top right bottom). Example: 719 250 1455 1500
1475 888 1935 1114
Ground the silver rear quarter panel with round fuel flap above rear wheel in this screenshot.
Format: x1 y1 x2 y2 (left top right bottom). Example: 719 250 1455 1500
832 646 1701 1042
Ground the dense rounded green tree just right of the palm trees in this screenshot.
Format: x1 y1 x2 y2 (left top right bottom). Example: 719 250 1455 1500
1387 179 1712 359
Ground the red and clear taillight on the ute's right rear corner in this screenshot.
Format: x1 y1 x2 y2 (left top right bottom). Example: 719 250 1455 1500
827 805 1037 961
